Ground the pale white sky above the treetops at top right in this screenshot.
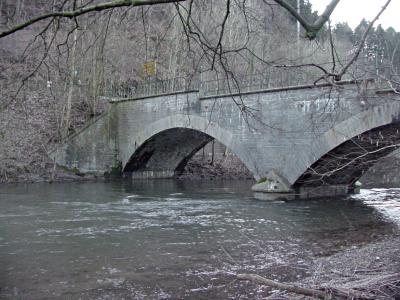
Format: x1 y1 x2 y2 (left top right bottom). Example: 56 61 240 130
310 0 400 31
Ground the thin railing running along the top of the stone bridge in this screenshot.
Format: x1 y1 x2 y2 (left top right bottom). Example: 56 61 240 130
104 59 400 102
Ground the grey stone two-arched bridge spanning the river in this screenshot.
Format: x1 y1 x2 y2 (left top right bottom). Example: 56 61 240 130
51 81 400 199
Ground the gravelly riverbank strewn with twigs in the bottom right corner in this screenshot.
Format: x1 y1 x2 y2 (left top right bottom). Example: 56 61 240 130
253 233 400 300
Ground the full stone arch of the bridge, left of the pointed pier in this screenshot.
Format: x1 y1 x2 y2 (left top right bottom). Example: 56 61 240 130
120 114 255 178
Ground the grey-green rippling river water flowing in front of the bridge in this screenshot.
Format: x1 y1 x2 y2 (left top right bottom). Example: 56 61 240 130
0 180 400 299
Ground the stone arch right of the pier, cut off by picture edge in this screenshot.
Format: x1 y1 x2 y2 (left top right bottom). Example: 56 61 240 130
290 101 400 187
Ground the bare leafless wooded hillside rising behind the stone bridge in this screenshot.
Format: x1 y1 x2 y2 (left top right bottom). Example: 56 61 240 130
0 0 400 182
